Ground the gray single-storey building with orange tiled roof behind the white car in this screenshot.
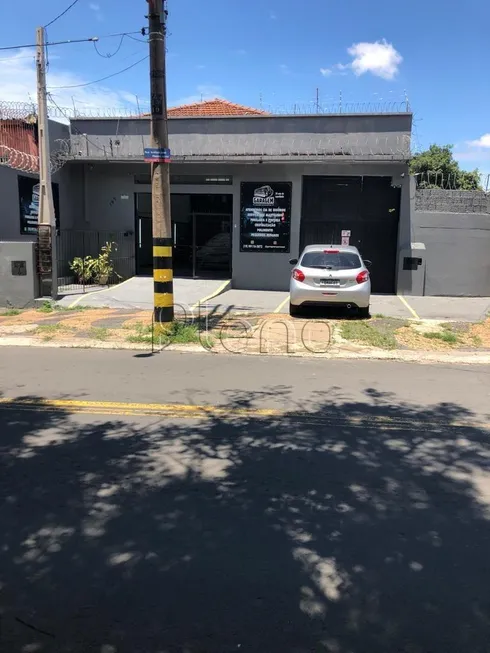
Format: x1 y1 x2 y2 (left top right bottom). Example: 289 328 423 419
54 101 412 292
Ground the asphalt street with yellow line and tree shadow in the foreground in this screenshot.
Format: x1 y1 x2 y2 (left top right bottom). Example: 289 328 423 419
0 348 490 653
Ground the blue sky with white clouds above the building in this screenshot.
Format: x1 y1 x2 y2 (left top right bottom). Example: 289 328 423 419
0 0 490 172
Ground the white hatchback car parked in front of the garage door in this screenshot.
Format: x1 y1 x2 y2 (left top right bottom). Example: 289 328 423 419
289 245 371 317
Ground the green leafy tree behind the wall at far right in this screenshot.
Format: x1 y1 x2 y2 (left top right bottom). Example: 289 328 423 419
410 145 481 190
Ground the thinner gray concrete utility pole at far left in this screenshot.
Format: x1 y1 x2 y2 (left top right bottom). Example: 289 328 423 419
36 27 58 299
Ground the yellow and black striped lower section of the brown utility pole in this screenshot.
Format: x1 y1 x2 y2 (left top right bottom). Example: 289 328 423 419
153 238 174 329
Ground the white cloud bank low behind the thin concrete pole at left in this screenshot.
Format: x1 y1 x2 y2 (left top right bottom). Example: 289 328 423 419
0 50 142 119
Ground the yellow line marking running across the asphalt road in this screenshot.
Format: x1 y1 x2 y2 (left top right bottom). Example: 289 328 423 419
0 397 490 430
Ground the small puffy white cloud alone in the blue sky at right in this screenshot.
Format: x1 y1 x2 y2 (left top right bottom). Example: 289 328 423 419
347 39 403 79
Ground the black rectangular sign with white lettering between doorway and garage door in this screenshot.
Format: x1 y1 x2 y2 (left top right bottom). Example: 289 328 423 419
240 181 292 253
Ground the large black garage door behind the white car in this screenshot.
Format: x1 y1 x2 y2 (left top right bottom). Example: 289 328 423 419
301 177 400 293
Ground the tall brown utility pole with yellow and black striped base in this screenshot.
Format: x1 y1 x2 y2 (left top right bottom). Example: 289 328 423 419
145 0 174 326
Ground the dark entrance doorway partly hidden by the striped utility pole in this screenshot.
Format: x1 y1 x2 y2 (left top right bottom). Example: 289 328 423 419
135 193 233 278
